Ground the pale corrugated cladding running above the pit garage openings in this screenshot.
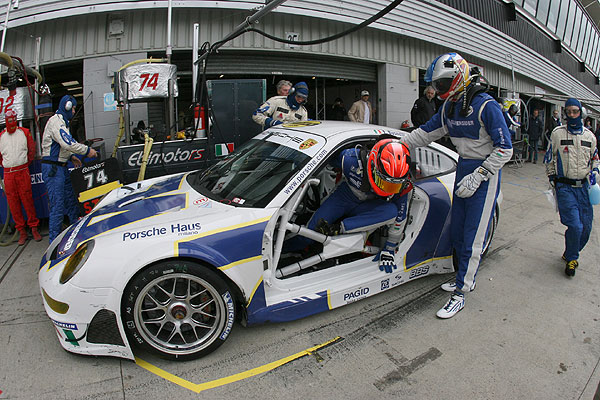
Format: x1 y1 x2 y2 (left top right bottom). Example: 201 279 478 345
0 0 600 100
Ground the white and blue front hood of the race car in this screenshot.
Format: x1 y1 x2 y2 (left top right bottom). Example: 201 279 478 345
55 174 231 259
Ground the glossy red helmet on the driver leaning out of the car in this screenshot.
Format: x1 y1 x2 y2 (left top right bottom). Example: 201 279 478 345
367 139 410 197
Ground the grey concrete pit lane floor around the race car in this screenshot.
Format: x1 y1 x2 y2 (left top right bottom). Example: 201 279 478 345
0 164 600 400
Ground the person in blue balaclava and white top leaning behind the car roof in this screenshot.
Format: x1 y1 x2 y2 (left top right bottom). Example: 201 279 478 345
252 82 308 129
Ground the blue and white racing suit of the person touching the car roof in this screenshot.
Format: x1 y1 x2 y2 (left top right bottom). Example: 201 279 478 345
402 93 512 292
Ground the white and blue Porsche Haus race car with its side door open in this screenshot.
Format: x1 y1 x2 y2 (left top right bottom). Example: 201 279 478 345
39 121 498 359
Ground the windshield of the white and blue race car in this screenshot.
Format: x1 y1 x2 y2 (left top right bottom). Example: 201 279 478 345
188 139 310 207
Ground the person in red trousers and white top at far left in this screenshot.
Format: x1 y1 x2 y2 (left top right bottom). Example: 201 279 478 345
0 110 42 246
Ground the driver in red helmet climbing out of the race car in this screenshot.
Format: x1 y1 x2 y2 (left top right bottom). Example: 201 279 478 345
308 138 413 273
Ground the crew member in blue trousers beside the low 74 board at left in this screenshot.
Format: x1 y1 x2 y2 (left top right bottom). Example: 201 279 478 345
42 95 97 243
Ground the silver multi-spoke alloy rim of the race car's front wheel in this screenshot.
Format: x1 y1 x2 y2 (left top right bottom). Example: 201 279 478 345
134 273 227 355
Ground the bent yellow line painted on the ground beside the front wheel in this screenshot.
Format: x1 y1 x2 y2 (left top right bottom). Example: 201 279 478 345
135 336 342 393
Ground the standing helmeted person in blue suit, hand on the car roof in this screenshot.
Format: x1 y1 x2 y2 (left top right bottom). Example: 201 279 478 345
402 53 512 318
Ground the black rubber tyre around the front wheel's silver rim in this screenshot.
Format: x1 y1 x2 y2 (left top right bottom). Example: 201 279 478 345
121 261 236 360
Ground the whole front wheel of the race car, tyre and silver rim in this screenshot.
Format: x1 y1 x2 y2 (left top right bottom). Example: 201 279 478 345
121 260 236 360
